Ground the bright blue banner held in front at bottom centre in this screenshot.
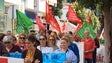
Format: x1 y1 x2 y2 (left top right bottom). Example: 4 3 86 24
42 53 66 63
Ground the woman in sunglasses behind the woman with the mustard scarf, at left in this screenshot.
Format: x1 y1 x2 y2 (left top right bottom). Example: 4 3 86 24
16 34 27 51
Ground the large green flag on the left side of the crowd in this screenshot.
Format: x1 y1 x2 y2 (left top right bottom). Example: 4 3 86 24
16 10 33 34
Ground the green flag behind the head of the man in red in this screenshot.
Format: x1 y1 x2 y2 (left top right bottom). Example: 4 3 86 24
77 22 96 39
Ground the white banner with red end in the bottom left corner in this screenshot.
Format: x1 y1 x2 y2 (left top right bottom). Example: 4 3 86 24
0 56 24 63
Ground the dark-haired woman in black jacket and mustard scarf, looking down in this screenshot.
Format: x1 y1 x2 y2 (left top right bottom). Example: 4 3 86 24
22 35 43 63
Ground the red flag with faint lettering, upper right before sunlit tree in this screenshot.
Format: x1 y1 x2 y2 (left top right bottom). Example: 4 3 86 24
68 5 81 24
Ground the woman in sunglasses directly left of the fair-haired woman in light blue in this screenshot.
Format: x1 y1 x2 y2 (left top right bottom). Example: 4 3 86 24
48 35 58 51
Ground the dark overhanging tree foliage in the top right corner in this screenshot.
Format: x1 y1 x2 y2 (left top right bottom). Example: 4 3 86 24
77 0 112 13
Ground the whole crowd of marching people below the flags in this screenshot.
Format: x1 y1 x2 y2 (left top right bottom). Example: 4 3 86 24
0 29 99 63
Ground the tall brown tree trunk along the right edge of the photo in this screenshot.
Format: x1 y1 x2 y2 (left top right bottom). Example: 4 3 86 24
104 1 112 63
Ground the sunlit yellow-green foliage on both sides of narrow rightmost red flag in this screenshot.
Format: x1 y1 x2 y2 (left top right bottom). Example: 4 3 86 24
73 2 100 30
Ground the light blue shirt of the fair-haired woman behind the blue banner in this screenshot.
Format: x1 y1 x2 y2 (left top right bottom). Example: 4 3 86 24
55 49 77 63
